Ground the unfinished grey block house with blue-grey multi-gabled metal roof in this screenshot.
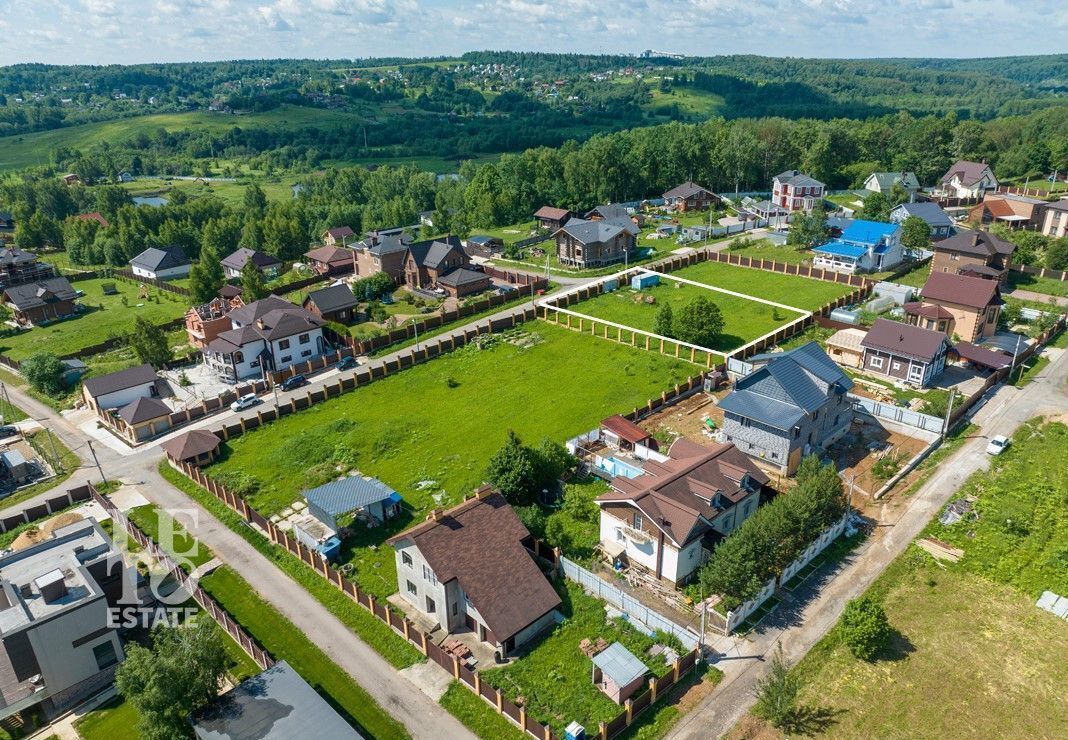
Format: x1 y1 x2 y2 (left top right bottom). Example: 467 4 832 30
720 342 853 475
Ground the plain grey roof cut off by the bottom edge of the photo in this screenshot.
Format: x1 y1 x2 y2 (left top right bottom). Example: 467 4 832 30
190 660 362 740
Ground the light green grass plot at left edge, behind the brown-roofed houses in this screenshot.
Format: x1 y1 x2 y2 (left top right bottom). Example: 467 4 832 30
0 279 189 360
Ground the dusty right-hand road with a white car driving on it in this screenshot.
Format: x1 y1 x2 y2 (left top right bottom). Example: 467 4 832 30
669 349 1068 740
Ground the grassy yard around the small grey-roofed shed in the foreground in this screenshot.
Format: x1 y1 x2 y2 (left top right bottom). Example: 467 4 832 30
482 582 670 736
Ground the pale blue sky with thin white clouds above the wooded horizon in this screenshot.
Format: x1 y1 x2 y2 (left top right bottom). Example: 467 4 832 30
0 0 1068 64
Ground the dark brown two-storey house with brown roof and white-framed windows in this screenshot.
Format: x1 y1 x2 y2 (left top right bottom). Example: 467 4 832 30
861 318 949 388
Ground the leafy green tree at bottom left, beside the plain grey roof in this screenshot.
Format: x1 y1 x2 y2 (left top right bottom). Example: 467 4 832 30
115 618 229 740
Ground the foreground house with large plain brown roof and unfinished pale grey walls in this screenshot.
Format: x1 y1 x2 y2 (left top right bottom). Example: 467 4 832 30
389 487 561 658
